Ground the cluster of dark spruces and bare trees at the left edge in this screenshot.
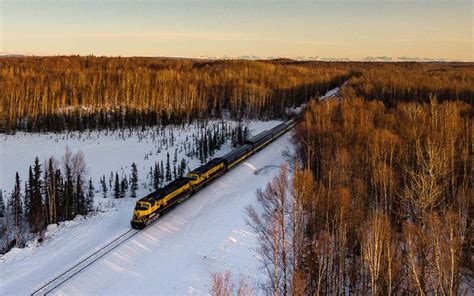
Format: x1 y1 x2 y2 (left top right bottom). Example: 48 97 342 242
0 149 94 252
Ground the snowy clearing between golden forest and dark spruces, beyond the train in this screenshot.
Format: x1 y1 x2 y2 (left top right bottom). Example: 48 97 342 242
0 121 280 197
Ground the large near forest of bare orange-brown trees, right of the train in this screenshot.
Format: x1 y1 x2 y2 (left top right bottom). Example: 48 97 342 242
248 97 474 295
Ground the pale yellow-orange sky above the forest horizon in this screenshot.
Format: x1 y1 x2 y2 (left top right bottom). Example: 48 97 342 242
0 0 474 61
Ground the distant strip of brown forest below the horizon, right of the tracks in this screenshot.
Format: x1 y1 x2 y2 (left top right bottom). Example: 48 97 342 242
344 63 474 106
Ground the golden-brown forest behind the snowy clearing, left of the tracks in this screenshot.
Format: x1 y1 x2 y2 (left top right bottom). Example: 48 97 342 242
0 56 349 132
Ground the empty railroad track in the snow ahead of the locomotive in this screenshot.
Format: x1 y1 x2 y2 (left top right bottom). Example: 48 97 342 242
31 229 139 295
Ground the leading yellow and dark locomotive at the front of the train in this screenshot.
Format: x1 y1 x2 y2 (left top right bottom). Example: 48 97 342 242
130 177 192 229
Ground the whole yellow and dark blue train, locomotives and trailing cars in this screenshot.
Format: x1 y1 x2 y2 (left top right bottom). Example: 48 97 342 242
130 118 296 229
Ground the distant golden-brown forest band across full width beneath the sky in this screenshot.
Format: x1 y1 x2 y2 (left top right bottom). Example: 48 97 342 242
0 56 474 133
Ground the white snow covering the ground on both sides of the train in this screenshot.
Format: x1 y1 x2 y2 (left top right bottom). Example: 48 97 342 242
0 122 292 295
